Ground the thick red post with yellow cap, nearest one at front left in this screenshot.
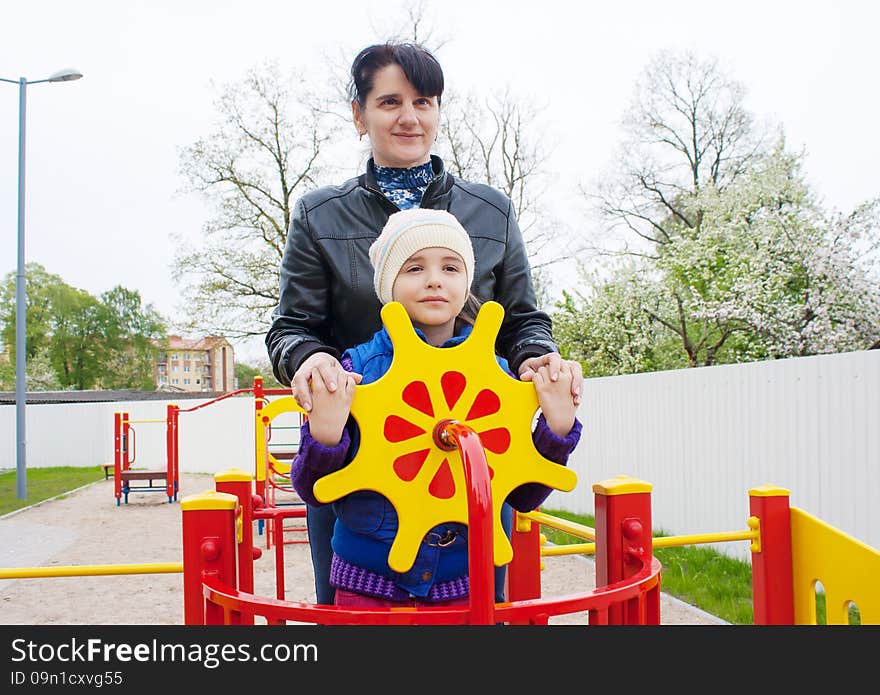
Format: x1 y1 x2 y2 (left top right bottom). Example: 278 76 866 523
180 490 238 625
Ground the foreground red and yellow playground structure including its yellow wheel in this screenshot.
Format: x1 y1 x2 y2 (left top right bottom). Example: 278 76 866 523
181 302 880 625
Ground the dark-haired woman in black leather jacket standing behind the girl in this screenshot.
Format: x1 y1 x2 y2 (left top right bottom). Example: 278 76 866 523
266 43 583 604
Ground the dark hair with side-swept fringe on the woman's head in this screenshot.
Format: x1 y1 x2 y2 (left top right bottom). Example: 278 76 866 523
348 41 443 106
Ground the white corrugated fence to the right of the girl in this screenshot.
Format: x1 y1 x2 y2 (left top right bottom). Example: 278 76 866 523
544 350 880 558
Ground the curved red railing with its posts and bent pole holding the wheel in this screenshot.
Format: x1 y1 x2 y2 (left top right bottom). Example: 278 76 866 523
181 416 661 625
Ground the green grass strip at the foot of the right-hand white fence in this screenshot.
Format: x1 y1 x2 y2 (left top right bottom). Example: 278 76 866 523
542 509 754 625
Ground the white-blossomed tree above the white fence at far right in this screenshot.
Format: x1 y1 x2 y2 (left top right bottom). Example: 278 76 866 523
676 150 880 364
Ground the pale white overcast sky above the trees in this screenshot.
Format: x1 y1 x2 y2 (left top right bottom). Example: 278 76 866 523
0 0 880 358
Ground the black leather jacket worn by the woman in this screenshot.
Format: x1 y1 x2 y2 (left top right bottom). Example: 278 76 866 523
266 156 558 385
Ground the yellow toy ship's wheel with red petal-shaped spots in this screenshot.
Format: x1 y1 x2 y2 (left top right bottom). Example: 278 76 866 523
314 302 577 572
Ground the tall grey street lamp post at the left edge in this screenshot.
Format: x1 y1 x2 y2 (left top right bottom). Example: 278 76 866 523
0 69 82 500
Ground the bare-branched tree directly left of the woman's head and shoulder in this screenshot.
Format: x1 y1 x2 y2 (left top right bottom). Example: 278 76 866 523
174 64 334 338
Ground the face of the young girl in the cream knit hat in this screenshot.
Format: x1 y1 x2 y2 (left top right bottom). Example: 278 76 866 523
391 247 470 346
